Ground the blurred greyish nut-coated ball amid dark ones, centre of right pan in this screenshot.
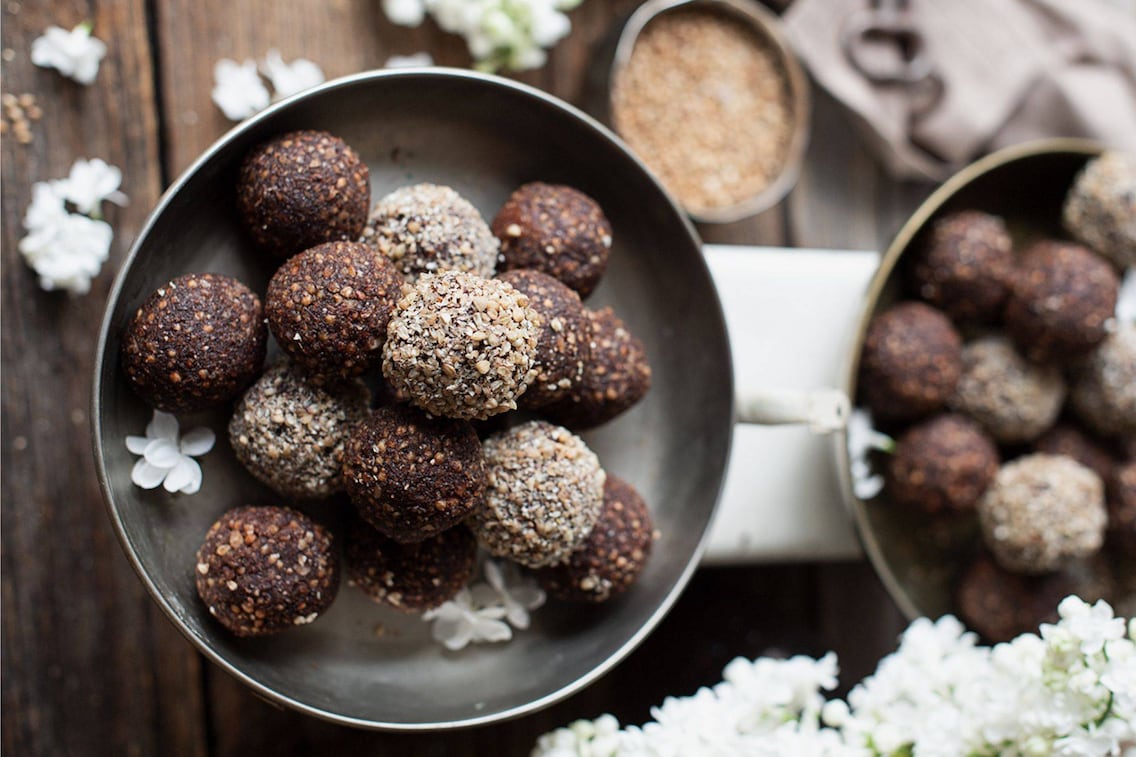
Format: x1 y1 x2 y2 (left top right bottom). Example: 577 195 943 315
951 336 1066 443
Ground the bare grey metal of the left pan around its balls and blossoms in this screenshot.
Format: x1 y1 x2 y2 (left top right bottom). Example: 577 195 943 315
93 69 733 730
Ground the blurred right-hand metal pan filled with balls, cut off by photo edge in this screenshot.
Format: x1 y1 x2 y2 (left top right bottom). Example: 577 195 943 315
842 140 1136 642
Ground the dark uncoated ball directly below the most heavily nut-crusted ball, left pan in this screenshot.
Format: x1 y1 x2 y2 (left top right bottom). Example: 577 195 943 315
343 405 485 543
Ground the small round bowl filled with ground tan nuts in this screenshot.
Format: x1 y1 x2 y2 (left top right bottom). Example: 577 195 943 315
605 0 810 223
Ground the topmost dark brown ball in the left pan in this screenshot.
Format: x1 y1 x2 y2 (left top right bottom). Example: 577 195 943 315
236 131 370 258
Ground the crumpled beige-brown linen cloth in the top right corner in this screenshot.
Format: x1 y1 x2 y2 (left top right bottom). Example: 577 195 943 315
784 0 1136 180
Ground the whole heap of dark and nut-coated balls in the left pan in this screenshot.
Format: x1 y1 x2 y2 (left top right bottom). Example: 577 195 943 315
122 131 654 637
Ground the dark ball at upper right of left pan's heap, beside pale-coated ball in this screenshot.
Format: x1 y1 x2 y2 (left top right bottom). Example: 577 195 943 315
492 182 611 297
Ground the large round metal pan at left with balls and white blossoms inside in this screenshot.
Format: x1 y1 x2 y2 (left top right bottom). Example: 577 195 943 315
93 68 733 730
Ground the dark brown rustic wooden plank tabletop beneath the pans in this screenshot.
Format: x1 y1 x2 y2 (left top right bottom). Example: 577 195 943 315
0 0 929 757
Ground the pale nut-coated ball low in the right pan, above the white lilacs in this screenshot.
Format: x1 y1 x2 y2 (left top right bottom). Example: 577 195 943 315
978 452 1108 574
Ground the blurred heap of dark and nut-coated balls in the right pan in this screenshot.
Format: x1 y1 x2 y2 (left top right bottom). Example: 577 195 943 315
859 153 1136 641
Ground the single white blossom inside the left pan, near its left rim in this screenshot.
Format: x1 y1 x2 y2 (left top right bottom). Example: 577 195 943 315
126 410 216 494
